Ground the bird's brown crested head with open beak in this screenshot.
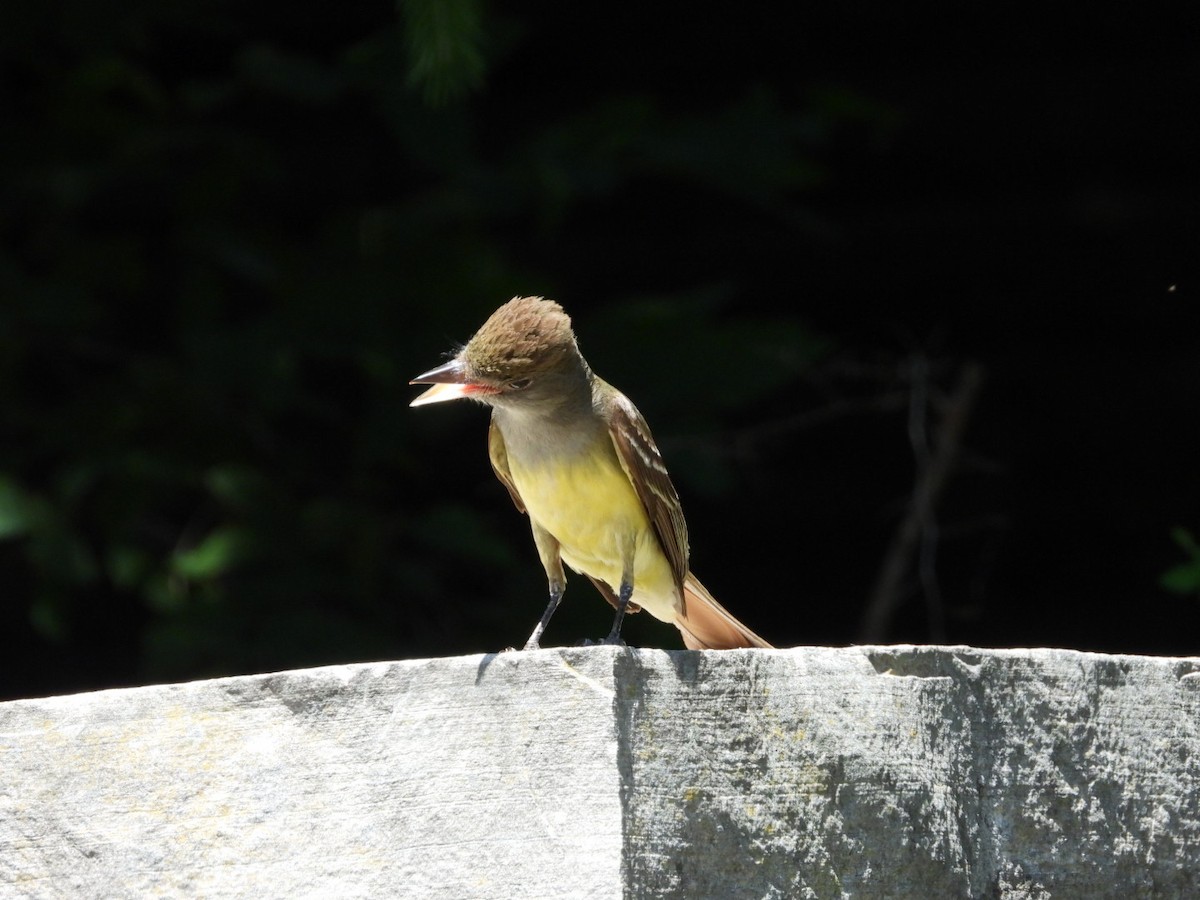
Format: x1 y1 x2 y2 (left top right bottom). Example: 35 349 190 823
409 296 589 408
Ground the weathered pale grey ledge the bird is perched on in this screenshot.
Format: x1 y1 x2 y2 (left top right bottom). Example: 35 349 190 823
0 647 1200 900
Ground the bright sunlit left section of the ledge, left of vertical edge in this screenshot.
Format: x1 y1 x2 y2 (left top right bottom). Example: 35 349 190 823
7 652 622 900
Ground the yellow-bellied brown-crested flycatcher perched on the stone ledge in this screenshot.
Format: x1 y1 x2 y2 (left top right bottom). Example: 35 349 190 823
412 296 770 650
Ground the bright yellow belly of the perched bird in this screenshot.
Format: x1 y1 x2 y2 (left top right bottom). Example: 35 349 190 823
509 448 679 622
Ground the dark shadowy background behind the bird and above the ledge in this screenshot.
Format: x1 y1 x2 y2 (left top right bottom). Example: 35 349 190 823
0 0 1200 697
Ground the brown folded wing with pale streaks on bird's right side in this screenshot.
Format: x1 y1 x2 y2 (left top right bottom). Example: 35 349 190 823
606 390 688 586
